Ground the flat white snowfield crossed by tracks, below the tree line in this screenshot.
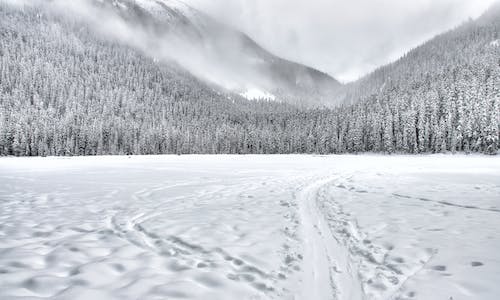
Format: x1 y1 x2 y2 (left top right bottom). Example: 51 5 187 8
0 155 500 300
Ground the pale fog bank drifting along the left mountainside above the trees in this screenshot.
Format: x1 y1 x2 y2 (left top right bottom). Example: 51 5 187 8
22 0 272 91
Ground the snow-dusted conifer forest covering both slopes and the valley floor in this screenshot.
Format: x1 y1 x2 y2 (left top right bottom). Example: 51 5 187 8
0 4 500 156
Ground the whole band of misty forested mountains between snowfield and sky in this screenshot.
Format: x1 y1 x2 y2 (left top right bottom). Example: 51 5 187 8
0 0 500 155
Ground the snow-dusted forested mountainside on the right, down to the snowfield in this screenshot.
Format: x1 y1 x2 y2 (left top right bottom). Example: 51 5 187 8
328 2 500 153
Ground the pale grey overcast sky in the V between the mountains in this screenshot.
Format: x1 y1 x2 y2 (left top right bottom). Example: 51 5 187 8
184 0 495 82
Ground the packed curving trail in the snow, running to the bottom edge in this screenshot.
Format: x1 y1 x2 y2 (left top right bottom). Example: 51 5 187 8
299 178 364 300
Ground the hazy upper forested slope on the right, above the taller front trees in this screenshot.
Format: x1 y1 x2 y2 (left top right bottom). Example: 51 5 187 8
336 1 500 103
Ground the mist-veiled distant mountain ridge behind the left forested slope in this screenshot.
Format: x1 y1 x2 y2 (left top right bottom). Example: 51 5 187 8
51 0 340 105
